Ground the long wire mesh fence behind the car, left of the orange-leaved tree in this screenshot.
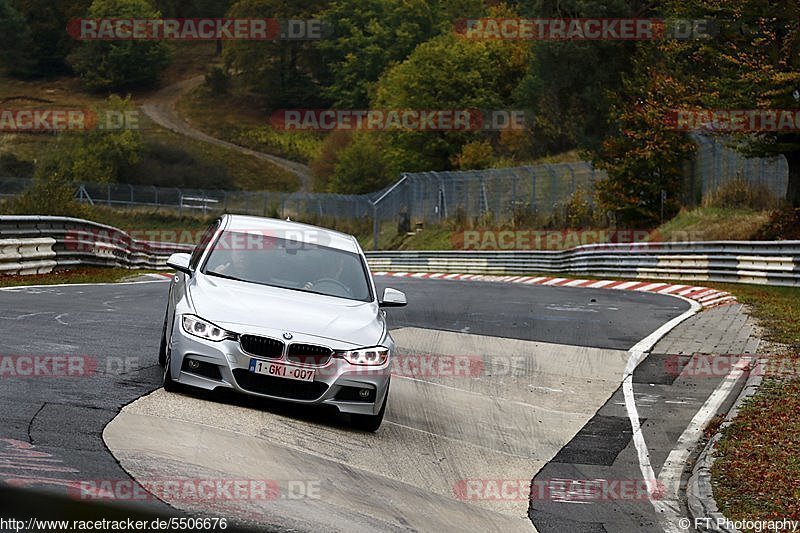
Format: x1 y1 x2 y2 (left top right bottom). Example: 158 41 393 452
0 163 604 223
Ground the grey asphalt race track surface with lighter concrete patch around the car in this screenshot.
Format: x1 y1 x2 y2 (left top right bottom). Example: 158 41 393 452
0 278 744 531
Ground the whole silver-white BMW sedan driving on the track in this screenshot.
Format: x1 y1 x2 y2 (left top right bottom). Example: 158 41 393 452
159 215 406 431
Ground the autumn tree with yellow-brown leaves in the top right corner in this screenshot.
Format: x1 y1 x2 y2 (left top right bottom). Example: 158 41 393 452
670 0 800 207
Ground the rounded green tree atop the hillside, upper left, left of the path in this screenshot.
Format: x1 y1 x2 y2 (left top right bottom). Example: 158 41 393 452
69 0 170 91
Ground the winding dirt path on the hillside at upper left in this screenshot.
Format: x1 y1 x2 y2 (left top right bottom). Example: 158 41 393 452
141 75 311 192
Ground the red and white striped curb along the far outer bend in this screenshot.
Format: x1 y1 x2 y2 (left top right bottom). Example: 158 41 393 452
373 272 736 308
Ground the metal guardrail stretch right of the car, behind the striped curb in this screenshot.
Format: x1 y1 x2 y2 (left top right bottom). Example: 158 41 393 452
367 241 800 286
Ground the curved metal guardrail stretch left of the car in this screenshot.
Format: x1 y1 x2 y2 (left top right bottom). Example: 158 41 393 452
0 216 192 274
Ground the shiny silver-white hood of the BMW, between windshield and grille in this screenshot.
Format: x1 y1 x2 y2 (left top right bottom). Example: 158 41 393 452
188 274 385 347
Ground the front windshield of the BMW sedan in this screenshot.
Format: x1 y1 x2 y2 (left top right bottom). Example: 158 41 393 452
203 231 372 302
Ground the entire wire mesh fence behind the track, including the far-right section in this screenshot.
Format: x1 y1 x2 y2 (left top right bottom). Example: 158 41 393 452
0 135 788 238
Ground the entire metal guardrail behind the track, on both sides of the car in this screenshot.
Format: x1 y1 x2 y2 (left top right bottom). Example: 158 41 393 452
0 216 800 286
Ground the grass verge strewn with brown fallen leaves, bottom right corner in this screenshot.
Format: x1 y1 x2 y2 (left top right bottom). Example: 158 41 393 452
711 285 800 520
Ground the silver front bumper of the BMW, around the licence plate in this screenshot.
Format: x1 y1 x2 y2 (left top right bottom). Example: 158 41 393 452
169 324 391 415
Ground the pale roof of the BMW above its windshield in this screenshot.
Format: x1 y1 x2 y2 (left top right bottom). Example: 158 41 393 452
223 215 360 253
